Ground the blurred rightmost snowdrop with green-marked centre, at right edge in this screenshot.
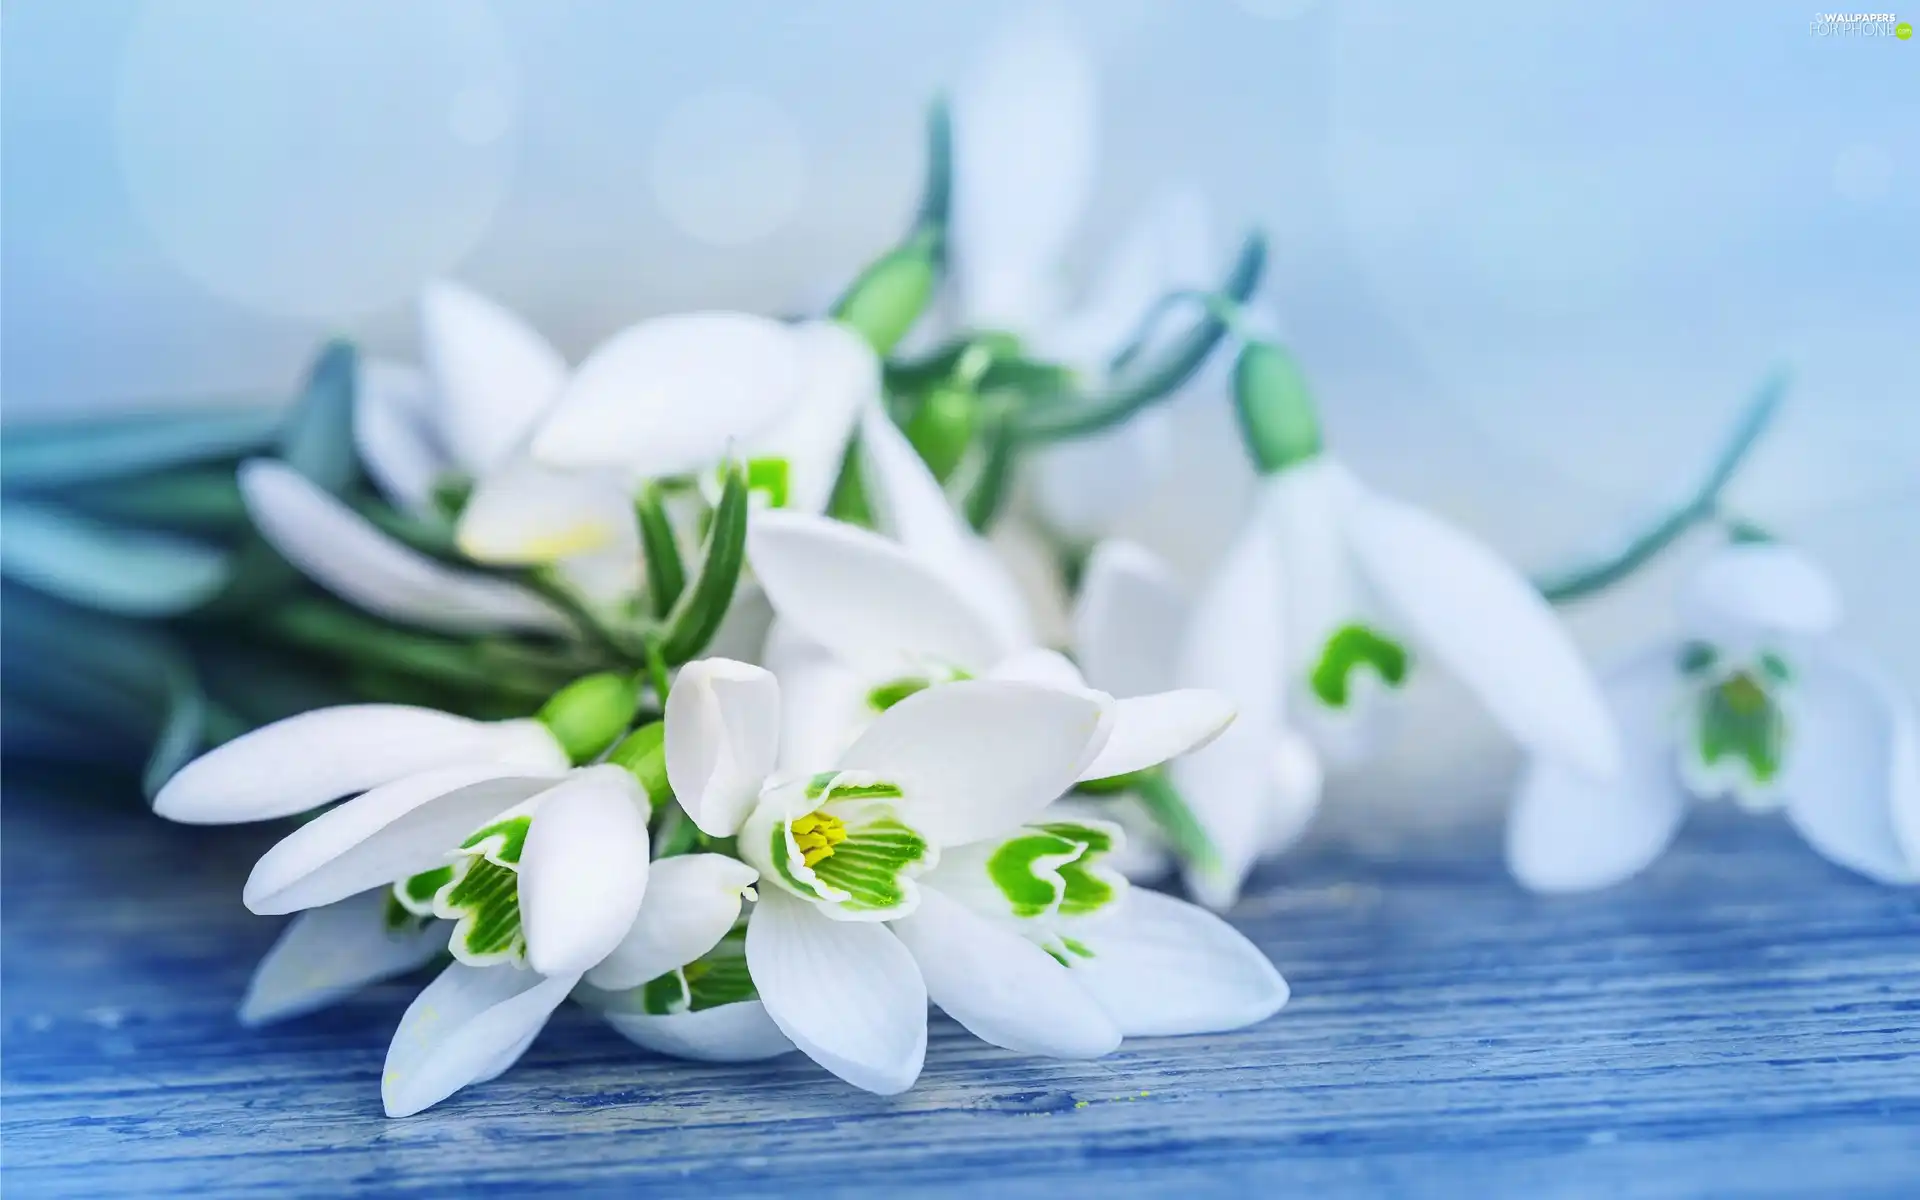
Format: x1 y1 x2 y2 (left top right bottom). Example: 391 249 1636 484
1507 543 1920 891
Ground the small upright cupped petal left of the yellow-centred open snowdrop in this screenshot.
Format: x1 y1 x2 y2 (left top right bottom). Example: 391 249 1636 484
666 659 780 837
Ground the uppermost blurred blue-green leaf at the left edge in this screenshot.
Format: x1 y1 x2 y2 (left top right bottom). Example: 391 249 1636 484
0 407 282 492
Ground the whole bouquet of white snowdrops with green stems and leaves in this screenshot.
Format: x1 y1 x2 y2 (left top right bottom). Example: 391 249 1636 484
0 32 1920 1116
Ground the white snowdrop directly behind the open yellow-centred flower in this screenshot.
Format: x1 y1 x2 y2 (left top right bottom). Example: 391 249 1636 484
747 413 1233 780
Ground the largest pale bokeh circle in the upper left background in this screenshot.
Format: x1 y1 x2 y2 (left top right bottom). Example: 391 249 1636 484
117 0 520 321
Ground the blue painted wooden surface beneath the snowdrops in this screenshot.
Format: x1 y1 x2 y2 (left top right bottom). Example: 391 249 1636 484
0 771 1920 1200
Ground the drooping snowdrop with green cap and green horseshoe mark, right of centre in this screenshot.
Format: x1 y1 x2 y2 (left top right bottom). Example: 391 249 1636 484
1192 342 1620 883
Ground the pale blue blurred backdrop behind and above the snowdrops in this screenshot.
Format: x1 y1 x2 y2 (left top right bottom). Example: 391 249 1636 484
0 0 1920 837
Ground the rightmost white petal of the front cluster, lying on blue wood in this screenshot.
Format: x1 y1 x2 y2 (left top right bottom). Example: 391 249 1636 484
1073 887 1286 1037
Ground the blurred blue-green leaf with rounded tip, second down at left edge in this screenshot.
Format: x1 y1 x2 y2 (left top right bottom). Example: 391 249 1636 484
0 499 232 618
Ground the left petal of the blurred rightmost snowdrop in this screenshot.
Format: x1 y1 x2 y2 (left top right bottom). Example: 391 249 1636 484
1507 643 1686 893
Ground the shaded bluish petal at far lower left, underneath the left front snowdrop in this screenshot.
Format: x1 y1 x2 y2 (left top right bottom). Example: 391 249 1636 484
240 887 447 1025
